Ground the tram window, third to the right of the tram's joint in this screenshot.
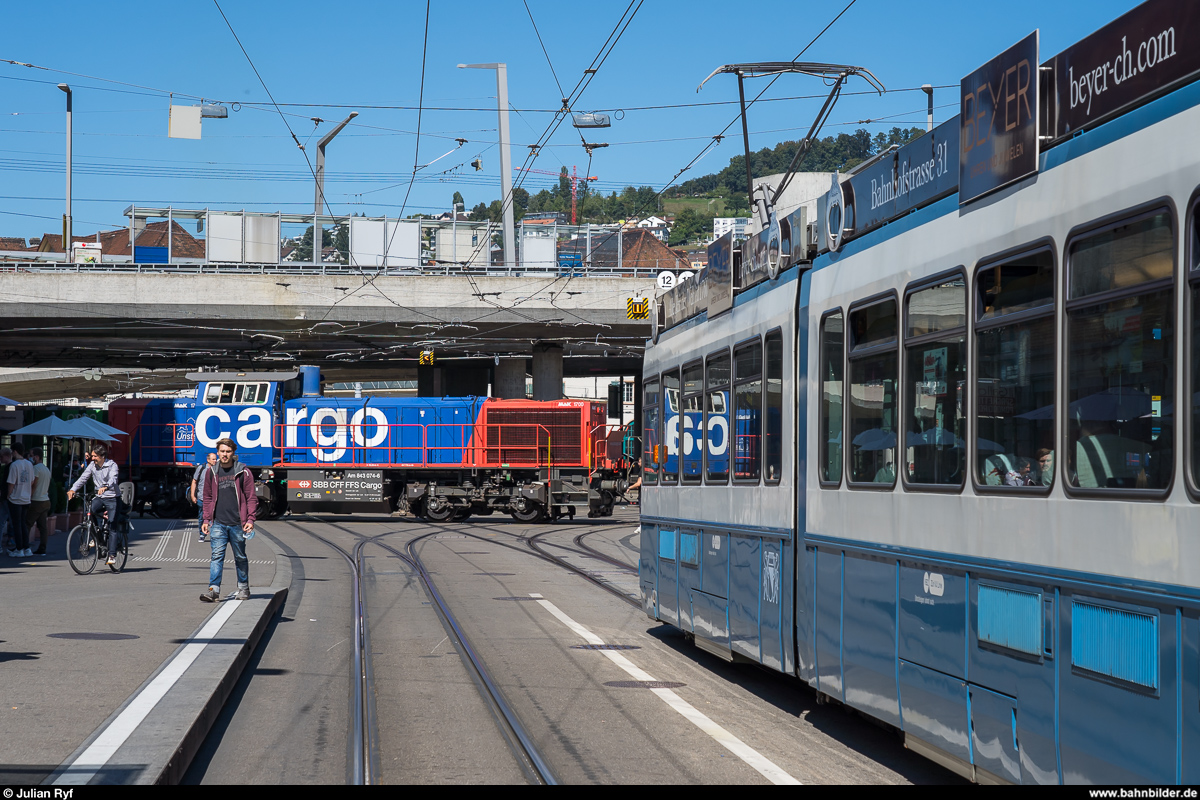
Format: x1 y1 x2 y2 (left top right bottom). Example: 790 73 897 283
904 275 967 486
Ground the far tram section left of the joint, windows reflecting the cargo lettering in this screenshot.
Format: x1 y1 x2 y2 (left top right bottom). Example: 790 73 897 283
640 269 799 672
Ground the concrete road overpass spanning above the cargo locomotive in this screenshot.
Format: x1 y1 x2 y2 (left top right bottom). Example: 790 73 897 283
0 272 653 393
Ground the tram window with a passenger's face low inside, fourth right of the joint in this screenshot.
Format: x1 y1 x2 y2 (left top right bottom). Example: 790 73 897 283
974 249 1055 491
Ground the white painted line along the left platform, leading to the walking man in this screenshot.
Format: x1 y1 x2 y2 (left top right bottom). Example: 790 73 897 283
54 600 241 786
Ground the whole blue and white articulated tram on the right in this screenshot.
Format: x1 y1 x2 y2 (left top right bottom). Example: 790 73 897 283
640 0 1200 783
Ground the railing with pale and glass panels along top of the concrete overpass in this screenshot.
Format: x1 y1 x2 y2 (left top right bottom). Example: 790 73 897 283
0 206 692 277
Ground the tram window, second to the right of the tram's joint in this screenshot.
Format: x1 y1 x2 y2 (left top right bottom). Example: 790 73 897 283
847 300 898 486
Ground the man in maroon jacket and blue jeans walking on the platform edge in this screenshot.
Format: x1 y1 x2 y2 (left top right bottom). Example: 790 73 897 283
200 439 258 603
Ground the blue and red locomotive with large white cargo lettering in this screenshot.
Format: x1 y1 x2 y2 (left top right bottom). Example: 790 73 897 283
109 367 637 522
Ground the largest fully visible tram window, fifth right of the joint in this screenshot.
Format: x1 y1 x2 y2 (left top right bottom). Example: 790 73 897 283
1067 210 1175 491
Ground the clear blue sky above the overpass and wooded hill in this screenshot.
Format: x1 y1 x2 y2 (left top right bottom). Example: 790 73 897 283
0 0 1136 236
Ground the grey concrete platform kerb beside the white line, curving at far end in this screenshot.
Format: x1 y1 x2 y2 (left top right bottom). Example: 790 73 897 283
42 536 292 786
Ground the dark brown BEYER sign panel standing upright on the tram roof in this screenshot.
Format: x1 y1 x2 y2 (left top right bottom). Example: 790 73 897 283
959 31 1039 204
